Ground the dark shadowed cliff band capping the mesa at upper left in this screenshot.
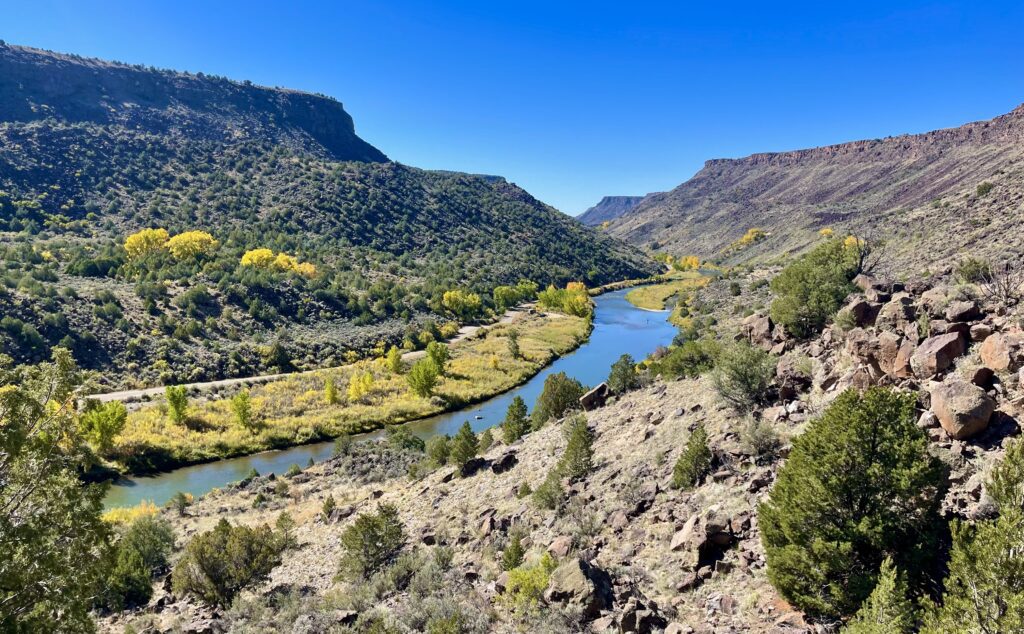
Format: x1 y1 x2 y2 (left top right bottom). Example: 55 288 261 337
0 45 387 162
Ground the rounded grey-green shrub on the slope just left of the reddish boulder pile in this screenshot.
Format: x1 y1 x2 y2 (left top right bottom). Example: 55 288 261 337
712 341 775 414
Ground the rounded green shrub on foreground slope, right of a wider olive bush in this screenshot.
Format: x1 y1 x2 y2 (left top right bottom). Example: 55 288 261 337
339 504 406 580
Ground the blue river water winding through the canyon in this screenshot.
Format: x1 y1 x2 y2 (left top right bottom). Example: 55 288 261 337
104 290 676 508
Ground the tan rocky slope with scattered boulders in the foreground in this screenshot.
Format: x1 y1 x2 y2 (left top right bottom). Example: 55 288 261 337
103 268 1024 633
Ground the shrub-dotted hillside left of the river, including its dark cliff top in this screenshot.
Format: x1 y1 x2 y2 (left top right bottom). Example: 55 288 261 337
0 45 654 387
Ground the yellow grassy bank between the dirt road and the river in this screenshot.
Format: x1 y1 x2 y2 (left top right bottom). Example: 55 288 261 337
111 313 591 474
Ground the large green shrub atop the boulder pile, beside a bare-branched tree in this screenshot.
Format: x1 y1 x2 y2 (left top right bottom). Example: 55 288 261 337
771 239 867 338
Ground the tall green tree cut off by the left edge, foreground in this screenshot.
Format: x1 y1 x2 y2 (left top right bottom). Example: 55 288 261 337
0 348 109 632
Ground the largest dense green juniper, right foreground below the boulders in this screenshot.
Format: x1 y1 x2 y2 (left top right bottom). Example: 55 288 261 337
758 387 945 617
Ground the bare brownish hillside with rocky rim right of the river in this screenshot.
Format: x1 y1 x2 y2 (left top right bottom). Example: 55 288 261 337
607 107 1024 267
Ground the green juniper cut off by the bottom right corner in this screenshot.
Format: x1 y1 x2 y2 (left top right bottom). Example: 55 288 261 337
922 440 1024 634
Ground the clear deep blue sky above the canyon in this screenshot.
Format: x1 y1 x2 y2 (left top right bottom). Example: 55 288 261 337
0 0 1024 214
